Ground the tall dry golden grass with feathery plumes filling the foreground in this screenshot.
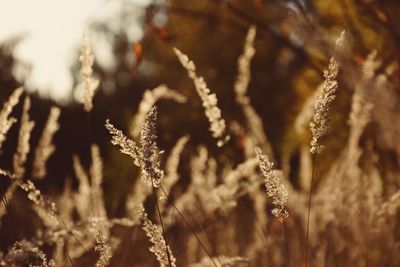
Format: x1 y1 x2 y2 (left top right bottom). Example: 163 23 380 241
0 27 400 267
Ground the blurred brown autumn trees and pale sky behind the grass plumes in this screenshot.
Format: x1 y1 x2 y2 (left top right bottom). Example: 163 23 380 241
0 0 400 266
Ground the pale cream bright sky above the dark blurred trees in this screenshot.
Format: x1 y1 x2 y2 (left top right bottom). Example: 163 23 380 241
0 0 149 101
